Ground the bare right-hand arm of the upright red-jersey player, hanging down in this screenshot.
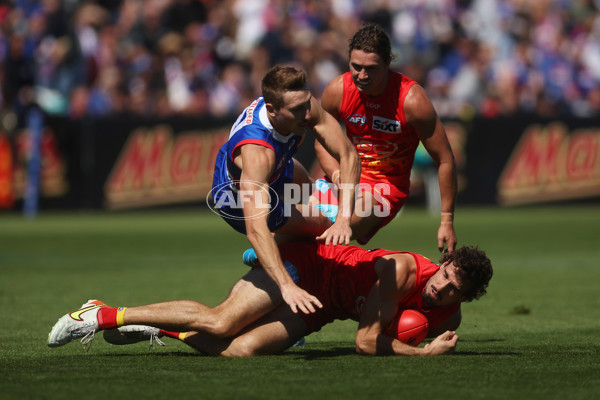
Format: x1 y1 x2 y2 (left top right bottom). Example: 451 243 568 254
404 85 457 251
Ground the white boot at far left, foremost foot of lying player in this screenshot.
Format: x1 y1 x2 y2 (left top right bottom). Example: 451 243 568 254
48 300 108 350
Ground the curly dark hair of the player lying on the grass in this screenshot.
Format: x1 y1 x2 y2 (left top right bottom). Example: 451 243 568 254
440 246 494 302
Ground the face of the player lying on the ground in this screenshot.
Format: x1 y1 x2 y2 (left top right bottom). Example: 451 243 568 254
423 263 468 307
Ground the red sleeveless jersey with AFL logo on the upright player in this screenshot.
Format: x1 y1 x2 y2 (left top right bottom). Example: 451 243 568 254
339 71 419 188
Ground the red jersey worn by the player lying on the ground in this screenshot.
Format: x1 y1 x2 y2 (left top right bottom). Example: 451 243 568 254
279 241 460 332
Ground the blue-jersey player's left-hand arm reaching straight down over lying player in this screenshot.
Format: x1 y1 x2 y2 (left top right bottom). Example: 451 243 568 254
239 144 322 314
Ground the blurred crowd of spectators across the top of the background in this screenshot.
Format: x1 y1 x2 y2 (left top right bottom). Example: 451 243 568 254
0 0 600 126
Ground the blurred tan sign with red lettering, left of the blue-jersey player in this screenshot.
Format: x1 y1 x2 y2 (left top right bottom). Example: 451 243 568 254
104 125 229 209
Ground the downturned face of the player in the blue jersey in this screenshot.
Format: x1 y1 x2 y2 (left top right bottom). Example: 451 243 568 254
271 90 312 135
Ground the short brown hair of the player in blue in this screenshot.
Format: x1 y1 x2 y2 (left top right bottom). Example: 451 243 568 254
261 65 308 109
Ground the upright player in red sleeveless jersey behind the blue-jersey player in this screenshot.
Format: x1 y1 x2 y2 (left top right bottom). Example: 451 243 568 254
315 24 457 251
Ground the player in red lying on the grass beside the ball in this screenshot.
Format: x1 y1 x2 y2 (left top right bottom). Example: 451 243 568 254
48 241 493 356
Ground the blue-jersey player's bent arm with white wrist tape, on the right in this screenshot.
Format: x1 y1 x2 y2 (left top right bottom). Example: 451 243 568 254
311 98 361 245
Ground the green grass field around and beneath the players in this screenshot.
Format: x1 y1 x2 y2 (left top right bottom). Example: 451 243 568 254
0 205 600 400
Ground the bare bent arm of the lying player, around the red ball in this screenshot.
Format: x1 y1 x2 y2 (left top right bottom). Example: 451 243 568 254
356 254 458 356
